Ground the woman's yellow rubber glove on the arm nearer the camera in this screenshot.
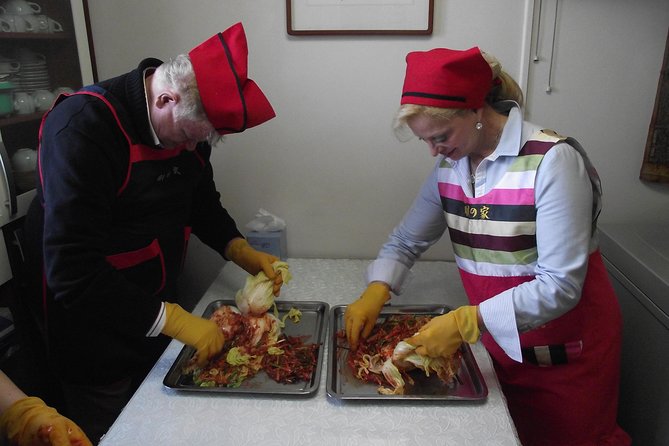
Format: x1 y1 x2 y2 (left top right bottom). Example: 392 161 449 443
405 305 481 358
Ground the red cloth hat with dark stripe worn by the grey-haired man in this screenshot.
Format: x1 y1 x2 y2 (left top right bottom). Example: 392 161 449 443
188 23 276 135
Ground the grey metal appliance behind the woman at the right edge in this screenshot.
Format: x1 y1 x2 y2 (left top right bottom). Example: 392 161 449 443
600 222 669 446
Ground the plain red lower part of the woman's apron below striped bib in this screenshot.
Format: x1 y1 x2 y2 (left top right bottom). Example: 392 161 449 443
460 251 631 446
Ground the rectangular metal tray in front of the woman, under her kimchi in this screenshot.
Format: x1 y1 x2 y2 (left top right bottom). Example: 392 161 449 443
327 305 488 401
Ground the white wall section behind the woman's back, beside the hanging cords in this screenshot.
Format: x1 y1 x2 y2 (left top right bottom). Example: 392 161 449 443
526 0 669 223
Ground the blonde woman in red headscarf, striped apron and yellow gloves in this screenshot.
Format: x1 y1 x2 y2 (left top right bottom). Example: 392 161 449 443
344 48 630 446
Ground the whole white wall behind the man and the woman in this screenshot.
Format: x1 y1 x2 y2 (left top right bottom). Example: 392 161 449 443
89 0 669 259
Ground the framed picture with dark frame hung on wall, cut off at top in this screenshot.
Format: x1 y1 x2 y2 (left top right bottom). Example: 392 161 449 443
286 0 434 36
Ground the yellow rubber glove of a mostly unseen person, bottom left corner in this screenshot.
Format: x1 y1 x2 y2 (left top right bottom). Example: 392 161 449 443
0 397 91 446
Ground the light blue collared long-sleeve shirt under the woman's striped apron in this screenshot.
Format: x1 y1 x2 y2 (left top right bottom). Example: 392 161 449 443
367 107 598 361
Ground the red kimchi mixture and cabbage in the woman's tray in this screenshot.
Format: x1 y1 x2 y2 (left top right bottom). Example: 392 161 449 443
337 314 461 394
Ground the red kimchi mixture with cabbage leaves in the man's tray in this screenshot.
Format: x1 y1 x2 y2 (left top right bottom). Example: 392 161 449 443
184 306 319 387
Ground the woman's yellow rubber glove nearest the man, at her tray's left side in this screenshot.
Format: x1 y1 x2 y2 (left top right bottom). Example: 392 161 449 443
344 282 390 350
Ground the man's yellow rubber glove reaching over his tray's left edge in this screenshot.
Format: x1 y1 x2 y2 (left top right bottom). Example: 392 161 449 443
163 302 225 367
